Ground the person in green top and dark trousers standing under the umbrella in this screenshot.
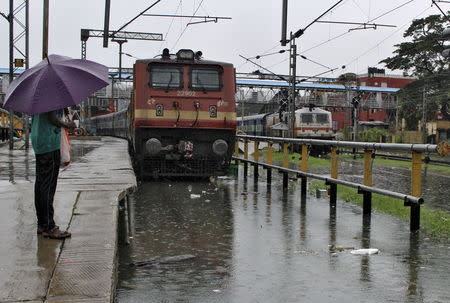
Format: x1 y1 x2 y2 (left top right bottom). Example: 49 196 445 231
31 110 75 239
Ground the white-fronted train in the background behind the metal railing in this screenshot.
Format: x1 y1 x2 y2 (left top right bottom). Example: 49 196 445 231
237 106 335 154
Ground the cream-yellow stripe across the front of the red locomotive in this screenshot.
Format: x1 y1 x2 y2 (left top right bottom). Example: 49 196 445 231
134 109 236 121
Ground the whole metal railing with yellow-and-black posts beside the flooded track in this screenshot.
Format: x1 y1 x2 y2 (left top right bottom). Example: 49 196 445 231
233 135 450 231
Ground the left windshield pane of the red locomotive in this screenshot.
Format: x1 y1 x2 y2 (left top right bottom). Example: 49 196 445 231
150 66 183 89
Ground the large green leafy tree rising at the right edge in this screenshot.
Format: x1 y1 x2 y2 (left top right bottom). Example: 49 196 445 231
380 15 450 129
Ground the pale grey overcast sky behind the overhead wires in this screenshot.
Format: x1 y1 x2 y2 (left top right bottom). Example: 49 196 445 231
0 0 450 77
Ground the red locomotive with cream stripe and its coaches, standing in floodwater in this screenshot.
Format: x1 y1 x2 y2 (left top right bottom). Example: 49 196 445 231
89 49 236 177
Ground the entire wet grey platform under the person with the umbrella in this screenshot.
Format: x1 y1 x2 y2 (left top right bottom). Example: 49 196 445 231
0 138 136 302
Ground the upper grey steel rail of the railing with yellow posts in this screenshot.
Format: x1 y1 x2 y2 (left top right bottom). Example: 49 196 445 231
236 135 438 153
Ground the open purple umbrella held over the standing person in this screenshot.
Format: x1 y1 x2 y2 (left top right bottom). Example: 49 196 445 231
3 55 109 115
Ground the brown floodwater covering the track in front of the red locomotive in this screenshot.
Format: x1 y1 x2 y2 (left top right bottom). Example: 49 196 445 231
116 169 450 303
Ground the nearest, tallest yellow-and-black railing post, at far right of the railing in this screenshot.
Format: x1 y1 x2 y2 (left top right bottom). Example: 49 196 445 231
408 152 422 231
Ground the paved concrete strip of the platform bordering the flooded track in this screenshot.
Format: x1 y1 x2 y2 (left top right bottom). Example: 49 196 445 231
44 138 137 303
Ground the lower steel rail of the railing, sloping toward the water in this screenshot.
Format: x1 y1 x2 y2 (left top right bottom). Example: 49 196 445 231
233 157 424 205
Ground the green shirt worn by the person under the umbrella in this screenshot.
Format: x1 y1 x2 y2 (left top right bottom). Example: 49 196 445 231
31 112 61 154
